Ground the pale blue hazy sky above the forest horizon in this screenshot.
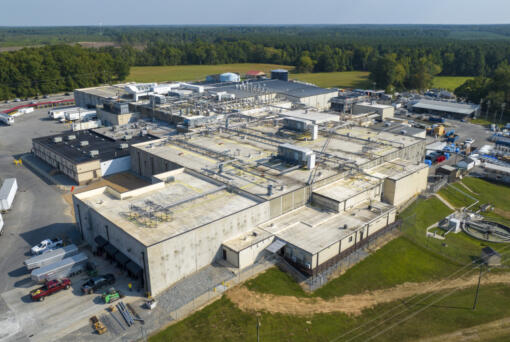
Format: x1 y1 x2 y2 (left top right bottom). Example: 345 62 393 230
0 0 510 26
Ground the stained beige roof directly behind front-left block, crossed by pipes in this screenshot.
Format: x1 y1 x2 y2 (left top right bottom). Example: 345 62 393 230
135 132 338 198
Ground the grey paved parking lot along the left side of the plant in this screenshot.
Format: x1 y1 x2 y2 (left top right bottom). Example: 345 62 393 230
0 109 140 341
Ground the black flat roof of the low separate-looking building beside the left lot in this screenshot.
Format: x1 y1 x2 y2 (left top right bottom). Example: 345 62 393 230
32 130 158 163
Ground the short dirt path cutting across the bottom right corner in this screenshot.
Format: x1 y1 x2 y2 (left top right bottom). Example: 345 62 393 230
418 317 510 342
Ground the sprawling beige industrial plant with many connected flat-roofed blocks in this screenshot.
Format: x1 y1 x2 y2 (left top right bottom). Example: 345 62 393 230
67 74 428 295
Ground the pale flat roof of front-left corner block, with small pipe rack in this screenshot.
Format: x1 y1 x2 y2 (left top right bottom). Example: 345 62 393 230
75 169 259 246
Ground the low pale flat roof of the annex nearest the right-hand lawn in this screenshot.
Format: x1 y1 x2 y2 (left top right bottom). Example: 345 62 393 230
259 201 394 255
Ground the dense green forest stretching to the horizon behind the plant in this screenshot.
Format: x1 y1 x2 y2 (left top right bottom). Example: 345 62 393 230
0 25 510 98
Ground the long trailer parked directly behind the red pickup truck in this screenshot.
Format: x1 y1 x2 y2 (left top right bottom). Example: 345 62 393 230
31 253 88 283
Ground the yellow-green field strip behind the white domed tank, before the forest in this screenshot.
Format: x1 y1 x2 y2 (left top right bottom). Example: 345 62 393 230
126 63 294 82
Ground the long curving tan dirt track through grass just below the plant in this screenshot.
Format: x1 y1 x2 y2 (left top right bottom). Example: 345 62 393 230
227 274 510 316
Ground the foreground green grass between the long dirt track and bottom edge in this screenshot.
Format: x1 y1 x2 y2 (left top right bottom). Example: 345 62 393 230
149 283 510 342
